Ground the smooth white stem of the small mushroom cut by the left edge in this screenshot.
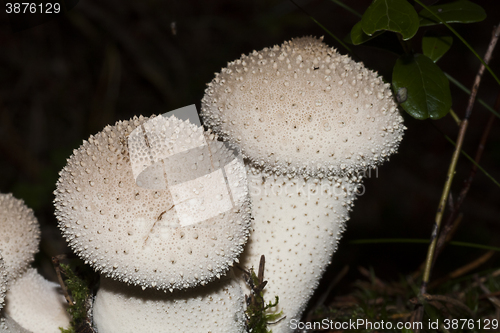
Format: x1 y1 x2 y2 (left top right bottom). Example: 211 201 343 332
4 268 70 333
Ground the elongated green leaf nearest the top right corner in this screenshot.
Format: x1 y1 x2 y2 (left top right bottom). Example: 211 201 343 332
418 0 486 27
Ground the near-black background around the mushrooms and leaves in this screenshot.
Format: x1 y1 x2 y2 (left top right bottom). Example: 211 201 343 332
0 0 500 314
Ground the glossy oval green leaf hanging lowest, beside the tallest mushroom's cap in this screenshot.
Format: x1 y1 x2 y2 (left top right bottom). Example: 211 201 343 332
392 54 451 120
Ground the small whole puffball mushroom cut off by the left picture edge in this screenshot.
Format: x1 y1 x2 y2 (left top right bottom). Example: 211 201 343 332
0 194 69 333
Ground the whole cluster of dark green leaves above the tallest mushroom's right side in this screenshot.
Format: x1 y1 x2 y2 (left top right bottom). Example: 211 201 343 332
346 0 486 120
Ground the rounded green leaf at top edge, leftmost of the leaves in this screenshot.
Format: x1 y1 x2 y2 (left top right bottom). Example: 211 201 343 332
361 0 419 40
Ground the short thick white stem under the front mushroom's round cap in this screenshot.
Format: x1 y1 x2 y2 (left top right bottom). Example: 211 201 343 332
93 272 245 333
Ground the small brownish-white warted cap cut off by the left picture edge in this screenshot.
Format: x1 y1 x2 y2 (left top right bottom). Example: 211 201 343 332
0 193 40 283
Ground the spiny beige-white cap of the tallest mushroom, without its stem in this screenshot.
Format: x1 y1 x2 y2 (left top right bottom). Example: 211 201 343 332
201 37 404 177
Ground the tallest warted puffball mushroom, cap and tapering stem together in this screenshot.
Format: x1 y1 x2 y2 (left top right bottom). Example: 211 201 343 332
201 37 405 333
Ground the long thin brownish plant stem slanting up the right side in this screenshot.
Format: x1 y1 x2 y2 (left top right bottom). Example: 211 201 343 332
417 24 500 295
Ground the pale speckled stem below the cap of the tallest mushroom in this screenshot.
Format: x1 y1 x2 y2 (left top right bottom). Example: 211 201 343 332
240 170 358 333
